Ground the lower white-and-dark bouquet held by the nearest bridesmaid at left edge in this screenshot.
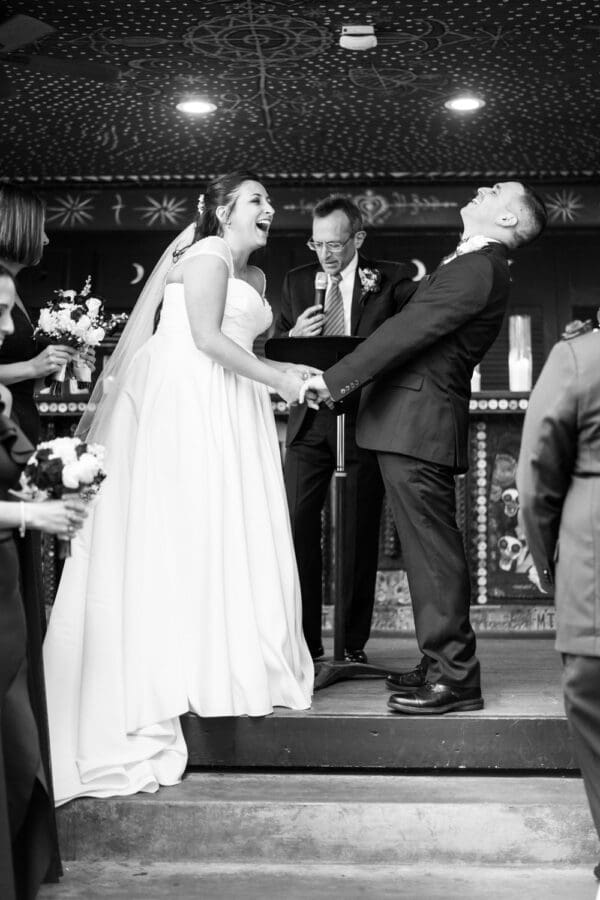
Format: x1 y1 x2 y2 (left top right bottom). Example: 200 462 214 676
12 437 106 557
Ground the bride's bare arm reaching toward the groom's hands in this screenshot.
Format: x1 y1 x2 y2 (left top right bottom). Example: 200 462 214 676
182 255 302 403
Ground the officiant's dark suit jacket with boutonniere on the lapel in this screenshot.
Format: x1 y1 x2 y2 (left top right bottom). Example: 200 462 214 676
274 254 416 444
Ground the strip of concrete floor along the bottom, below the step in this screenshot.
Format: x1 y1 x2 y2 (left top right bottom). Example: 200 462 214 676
39 863 597 900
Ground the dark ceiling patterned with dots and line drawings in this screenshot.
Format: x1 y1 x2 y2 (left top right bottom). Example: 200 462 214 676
0 0 600 184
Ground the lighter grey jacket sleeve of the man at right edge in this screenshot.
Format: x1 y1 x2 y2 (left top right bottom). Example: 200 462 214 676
517 341 577 588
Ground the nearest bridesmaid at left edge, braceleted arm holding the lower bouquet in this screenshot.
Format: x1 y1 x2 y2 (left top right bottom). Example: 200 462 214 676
0 267 85 900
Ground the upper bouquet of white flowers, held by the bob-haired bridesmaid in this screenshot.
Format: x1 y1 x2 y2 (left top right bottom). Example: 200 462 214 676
34 276 127 383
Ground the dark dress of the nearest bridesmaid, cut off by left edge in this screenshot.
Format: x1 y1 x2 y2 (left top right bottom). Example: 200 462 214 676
0 408 56 900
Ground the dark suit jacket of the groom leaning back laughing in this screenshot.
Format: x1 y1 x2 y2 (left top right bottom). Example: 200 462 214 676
325 243 510 472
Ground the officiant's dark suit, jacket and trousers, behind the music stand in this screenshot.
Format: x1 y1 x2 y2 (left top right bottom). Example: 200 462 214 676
276 254 416 654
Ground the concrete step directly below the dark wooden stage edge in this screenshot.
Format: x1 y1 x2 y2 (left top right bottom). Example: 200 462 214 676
59 773 598 864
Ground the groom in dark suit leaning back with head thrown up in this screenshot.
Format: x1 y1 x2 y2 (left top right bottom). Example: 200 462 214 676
307 182 546 715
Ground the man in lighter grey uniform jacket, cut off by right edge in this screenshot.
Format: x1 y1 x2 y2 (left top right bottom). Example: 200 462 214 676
517 323 600 880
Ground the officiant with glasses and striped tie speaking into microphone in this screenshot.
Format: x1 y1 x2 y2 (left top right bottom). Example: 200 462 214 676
275 195 415 662
